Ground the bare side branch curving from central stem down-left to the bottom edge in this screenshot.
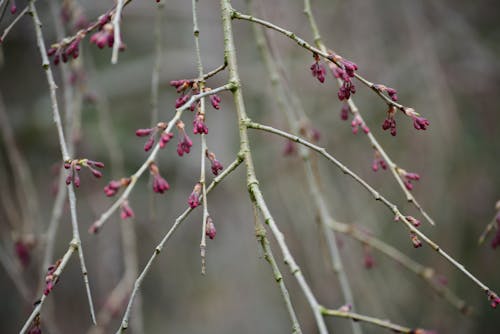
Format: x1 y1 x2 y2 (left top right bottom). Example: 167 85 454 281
116 154 244 334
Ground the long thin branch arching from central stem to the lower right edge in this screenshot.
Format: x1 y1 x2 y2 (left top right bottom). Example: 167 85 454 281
245 120 497 306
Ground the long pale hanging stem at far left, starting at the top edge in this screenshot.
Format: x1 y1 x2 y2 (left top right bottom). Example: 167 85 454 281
29 0 96 323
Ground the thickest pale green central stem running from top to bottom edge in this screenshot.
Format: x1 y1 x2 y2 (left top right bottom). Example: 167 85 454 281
220 0 328 334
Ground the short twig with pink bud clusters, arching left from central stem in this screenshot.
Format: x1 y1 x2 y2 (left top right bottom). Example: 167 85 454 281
89 83 234 233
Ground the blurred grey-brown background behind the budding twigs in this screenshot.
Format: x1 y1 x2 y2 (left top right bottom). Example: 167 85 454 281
0 0 500 334
